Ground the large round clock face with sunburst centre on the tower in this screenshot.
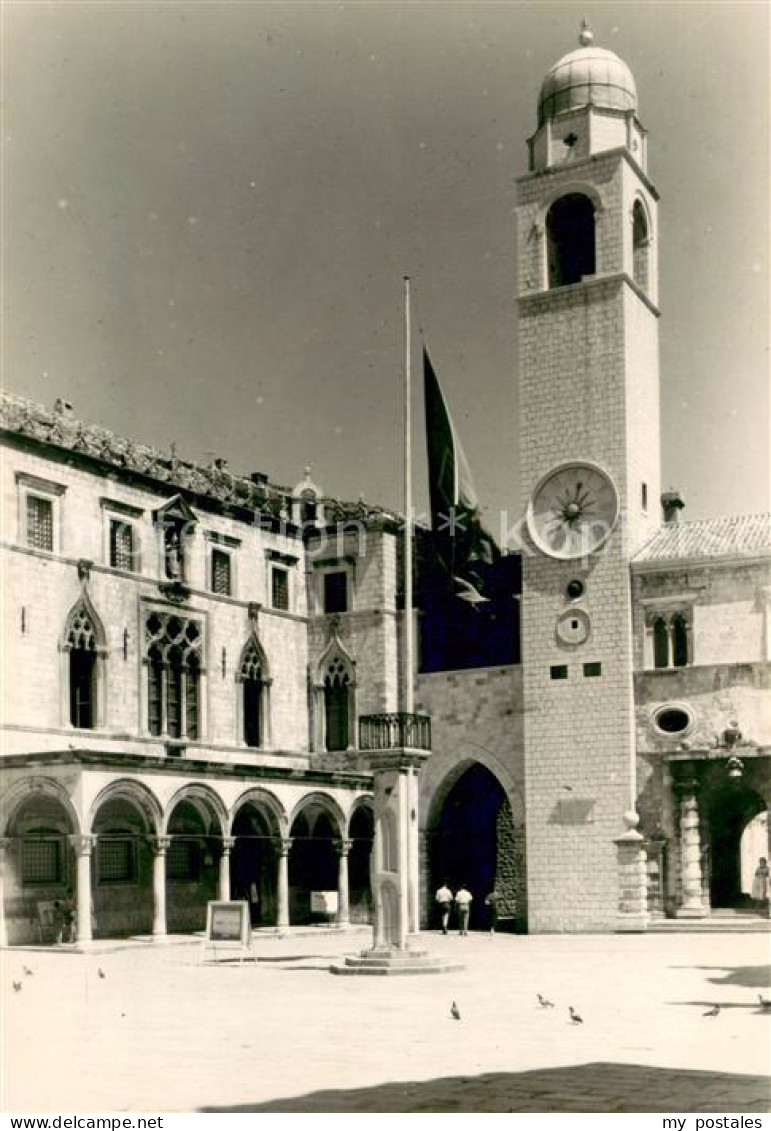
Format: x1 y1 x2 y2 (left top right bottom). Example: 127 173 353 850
527 464 618 559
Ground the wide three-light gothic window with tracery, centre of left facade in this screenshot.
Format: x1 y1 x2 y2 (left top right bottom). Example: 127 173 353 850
145 612 202 740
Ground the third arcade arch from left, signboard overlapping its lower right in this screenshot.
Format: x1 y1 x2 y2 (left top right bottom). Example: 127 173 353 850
166 797 222 934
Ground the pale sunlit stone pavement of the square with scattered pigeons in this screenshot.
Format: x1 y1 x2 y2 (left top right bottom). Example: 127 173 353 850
1 931 771 1114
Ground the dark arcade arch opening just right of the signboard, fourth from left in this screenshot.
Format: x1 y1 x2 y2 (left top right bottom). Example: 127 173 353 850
231 801 280 926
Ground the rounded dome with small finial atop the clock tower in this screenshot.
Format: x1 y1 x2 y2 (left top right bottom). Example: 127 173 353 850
538 20 638 126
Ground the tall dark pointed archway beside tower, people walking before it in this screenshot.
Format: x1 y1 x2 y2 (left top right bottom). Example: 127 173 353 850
431 762 516 930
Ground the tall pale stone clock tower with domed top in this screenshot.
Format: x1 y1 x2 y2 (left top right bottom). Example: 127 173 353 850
517 24 660 931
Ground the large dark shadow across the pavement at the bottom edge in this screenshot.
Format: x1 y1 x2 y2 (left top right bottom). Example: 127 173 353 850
199 1063 771 1114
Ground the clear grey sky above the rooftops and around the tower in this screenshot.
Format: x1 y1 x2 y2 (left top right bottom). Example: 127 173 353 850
1 0 771 533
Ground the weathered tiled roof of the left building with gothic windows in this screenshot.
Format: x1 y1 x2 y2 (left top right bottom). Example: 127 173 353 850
0 392 396 523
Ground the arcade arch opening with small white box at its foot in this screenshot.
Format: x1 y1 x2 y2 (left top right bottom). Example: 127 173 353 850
289 802 341 923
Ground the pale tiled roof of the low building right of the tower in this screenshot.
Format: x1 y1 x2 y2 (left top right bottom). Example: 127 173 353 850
634 513 771 563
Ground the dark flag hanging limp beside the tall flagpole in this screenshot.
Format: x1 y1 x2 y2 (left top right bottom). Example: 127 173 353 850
423 346 500 583
